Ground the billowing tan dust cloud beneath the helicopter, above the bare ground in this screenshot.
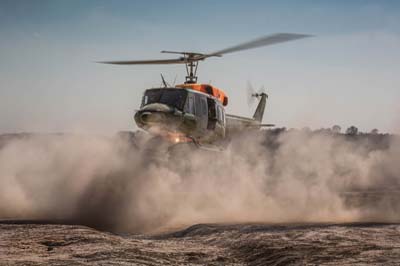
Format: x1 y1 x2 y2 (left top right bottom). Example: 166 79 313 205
0 130 400 232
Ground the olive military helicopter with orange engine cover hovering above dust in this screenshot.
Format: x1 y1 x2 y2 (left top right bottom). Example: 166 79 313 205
98 33 311 146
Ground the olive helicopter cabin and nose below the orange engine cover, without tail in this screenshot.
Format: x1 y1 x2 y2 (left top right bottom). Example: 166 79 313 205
135 84 227 143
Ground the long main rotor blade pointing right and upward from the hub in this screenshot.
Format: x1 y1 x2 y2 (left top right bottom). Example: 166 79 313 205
205 33 312 58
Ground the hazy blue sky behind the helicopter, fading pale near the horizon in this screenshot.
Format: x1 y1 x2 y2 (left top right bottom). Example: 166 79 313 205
0 0 400 133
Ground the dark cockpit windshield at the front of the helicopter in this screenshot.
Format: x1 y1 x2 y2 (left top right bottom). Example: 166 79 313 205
142 88 187 110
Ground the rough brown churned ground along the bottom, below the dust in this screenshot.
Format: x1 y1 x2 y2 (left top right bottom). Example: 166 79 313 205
0 221 400 265
